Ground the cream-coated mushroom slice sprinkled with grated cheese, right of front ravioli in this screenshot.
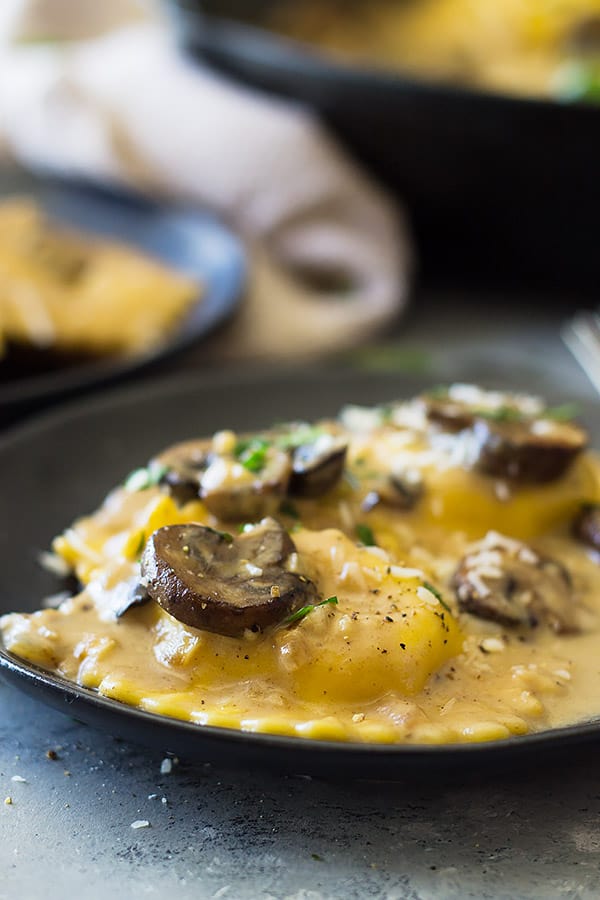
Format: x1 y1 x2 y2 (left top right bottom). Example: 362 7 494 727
452 533 577 632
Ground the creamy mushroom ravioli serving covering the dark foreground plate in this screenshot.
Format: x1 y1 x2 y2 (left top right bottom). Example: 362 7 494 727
0 385 600 743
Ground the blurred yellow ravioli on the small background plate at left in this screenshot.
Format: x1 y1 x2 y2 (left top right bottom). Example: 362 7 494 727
0 198 199 378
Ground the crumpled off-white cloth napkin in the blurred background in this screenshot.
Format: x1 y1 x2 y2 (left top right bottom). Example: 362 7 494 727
0 0 410 358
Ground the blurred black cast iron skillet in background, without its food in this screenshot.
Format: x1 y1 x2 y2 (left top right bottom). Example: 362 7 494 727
171 0 600 290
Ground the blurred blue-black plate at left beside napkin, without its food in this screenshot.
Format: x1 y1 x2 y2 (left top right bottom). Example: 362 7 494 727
0 171 245 422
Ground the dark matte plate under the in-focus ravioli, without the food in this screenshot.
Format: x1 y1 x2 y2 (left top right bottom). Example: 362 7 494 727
0 371 600 779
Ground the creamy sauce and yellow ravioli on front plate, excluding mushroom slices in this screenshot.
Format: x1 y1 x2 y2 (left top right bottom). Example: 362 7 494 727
1 394 600 743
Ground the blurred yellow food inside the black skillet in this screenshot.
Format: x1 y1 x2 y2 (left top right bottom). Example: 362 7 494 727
267 0 600 102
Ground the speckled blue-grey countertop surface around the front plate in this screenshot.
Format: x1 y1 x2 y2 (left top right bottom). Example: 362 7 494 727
0 295 600 900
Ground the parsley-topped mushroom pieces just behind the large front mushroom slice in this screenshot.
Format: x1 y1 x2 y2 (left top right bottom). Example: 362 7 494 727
158 437 292 522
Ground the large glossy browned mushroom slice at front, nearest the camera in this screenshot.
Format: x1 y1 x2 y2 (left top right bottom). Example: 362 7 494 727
142 518 317 637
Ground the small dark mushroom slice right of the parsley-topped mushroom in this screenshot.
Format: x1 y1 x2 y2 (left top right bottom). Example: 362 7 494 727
288 434 348 497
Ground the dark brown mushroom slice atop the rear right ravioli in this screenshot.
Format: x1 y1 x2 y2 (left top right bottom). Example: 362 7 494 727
473 418 587 484
